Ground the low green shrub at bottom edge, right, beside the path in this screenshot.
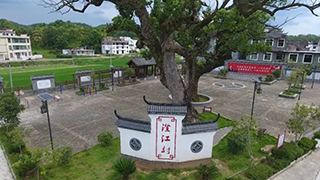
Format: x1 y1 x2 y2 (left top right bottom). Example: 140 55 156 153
245 164 276 180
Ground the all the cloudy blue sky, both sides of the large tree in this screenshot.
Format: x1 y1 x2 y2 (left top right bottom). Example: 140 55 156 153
0 0 320 35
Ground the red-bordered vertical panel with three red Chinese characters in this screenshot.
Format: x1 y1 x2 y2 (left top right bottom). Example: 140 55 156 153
156 116 177 160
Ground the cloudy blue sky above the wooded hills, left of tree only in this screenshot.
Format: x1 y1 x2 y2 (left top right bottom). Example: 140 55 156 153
0 0 118 26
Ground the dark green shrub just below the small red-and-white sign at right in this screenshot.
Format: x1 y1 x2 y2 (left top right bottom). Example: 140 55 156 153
271 142 304 161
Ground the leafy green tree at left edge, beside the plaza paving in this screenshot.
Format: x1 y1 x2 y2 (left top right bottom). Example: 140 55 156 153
0 93 25 130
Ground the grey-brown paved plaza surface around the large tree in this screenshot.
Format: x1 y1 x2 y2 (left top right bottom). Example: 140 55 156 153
20 74 320 152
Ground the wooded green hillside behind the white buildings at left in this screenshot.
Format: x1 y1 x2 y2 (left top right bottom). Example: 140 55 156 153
0 19 135 53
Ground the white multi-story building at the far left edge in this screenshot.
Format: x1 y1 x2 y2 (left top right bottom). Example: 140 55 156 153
0 29 32 61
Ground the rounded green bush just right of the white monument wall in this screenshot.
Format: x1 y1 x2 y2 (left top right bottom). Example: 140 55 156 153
227 130 248 154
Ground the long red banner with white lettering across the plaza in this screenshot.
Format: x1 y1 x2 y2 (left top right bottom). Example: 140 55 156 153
228 62 282 75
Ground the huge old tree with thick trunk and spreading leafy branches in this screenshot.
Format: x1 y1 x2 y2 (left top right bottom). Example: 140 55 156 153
42 0 319 119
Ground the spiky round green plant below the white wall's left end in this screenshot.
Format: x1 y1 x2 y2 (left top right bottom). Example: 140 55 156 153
113 158 136 180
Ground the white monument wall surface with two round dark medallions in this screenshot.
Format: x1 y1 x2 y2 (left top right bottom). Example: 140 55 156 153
118 114 216 162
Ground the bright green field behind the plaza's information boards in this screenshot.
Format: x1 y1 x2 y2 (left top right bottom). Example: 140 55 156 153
0 57 130 87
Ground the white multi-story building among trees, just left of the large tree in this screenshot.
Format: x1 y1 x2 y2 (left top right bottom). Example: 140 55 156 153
101 37 137 54
